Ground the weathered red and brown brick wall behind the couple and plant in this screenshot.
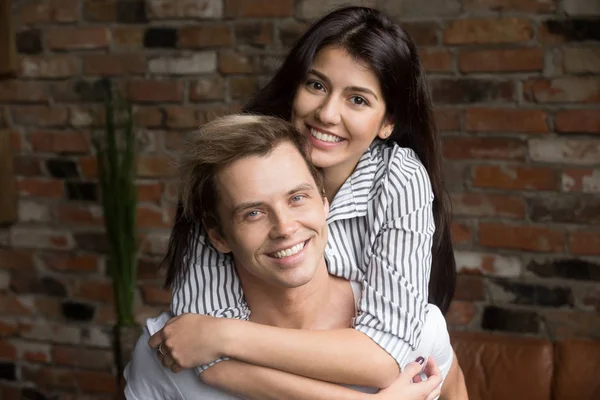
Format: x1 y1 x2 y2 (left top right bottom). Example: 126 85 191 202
0 0 600 399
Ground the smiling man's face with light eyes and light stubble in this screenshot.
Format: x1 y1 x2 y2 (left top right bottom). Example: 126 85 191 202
209 143 329 288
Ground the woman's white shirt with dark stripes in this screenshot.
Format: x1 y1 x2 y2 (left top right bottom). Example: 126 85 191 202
171 140 435 372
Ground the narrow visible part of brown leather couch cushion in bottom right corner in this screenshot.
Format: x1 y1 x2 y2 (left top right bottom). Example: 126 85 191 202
552 339 600 400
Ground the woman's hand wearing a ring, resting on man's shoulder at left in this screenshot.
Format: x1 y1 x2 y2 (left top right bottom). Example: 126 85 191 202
148 314 226 372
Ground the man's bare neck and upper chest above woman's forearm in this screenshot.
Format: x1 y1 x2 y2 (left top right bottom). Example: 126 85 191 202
238 260 354 329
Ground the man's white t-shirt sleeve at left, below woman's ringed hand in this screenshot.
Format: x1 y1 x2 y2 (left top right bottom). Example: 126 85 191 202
124 327 184 400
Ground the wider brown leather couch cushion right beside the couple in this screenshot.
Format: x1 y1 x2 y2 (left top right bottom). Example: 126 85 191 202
450 332 553 400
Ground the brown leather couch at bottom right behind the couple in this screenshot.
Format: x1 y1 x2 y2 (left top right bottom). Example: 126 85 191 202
450 332 600 400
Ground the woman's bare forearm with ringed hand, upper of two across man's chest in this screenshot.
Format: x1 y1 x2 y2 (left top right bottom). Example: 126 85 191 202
148 314 399 388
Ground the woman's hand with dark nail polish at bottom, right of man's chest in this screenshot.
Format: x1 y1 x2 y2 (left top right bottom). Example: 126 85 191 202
374 357 442 400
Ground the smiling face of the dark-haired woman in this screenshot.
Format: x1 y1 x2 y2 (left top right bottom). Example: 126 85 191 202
292 46 393 180
